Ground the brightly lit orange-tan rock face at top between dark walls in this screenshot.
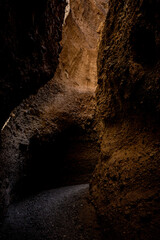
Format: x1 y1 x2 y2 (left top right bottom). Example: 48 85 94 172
55 0 108 91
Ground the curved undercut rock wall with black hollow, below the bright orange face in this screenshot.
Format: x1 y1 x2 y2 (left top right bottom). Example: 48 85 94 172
0 85 99 203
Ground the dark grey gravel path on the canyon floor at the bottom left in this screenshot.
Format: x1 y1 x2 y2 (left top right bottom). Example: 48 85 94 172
0 184 102 240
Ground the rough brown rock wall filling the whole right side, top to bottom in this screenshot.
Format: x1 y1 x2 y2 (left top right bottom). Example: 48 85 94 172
91 0 160 240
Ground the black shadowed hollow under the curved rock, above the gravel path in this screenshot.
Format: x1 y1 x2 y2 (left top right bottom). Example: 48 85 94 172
14 126 98 198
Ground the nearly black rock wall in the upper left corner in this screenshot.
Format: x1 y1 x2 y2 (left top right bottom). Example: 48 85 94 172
0 0 65 126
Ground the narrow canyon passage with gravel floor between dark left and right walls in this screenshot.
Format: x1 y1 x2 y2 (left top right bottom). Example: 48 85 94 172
0 0 107 240
